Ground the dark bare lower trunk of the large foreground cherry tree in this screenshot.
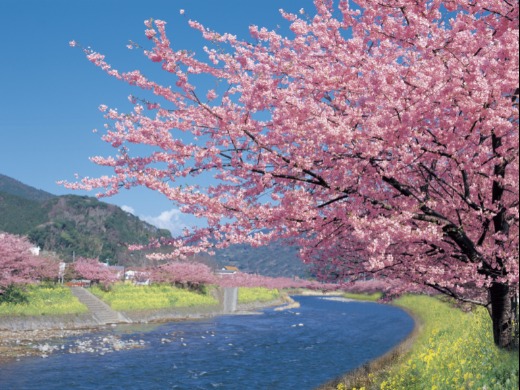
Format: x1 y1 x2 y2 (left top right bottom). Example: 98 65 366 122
489 283 514 348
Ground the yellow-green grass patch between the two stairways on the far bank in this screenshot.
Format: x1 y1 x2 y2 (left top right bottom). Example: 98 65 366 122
91 283 218 311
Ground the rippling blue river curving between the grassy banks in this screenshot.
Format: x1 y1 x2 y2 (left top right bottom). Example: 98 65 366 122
0 297 413 390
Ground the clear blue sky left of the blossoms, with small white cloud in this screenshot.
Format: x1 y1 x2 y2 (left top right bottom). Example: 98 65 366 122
0 0 313 235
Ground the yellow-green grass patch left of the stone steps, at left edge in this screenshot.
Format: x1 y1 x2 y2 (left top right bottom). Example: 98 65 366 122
0 285 88 316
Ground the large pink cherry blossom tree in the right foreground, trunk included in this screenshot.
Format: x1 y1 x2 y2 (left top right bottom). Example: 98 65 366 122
68 0 519 347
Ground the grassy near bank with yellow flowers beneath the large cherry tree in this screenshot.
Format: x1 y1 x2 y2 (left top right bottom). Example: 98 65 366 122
322 295 519 390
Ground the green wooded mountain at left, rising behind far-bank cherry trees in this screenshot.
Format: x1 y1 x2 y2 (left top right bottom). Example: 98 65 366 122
0 175 171 265
